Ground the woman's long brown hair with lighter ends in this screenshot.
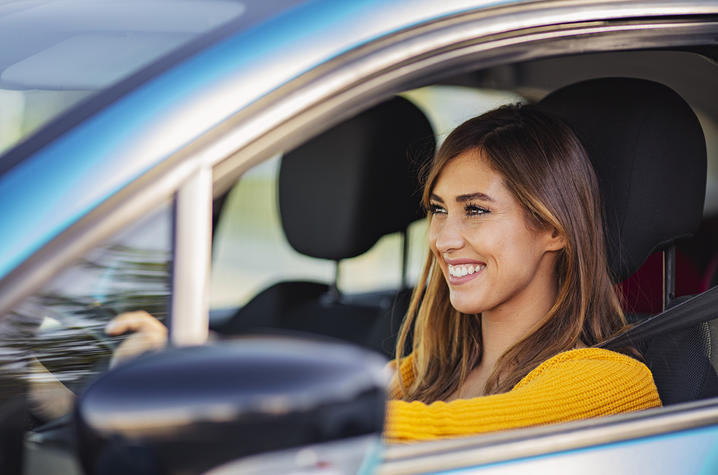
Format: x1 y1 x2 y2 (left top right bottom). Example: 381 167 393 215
393 105 625 403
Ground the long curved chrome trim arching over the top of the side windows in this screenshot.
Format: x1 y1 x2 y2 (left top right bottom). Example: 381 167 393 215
0 7 718 326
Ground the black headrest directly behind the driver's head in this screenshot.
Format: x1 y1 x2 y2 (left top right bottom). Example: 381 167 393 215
540 78 706 282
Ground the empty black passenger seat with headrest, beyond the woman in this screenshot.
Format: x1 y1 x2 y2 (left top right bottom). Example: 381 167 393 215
216 97 435 354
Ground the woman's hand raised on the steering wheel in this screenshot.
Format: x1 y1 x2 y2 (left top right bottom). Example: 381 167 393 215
105 310 167 368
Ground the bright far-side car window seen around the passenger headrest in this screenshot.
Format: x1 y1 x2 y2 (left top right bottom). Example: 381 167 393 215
210 86 523 319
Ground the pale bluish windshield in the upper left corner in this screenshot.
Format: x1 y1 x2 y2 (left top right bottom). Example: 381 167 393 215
0 0 298 154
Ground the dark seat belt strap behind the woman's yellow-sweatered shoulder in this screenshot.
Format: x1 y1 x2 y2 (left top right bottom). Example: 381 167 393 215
596 286 718 350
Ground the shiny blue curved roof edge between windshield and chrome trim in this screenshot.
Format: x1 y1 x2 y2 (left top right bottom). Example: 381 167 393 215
0 0 524 278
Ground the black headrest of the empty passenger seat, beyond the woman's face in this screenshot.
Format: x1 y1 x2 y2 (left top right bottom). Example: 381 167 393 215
279 97 435 260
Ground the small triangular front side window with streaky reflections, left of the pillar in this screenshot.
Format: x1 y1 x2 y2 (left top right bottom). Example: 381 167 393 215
0 205 172 426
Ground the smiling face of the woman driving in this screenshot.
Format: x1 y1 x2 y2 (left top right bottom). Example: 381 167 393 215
429 150 563 315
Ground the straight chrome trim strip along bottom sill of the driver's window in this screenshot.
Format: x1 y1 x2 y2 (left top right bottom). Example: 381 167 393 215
378 399 718 475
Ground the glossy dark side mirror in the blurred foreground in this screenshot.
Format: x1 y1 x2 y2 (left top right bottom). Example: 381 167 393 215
75 337 386 474
